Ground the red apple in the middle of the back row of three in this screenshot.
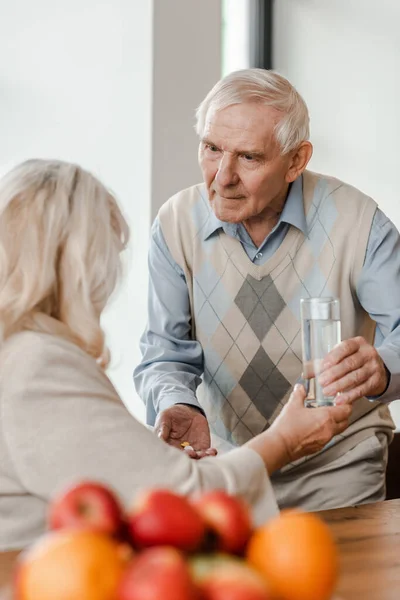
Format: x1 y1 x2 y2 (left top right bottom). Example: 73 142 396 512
128 490 205 552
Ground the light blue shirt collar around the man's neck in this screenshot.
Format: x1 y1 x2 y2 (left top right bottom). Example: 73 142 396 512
203 176 307 240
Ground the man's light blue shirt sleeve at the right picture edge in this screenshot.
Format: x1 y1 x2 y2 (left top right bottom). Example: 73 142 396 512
357 209 400 402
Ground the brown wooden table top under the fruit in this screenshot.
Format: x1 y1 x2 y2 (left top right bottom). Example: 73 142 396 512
0 500 400 600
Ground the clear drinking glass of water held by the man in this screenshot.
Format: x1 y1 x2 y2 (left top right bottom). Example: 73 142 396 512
300 298 340 407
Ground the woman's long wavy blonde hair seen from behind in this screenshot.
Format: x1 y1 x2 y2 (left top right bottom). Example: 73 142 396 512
0 160 129 367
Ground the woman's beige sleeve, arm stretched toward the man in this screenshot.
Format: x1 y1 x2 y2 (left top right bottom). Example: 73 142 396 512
0 336 277 522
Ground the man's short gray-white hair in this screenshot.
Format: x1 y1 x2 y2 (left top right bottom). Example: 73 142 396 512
196 69 310 154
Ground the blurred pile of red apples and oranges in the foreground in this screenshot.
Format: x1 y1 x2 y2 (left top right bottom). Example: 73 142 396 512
15 481 338 600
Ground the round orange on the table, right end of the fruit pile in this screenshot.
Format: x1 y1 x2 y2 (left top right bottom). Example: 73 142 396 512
247 510 338 600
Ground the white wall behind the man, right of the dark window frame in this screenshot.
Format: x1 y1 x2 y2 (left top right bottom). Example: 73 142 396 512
273 0 400 425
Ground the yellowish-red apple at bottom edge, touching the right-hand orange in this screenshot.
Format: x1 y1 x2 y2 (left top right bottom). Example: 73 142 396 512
191 554 273 600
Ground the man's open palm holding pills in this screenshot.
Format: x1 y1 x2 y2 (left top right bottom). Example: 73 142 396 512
154 404 217 458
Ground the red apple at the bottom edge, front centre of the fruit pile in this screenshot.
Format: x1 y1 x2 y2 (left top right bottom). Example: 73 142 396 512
116 546 198 600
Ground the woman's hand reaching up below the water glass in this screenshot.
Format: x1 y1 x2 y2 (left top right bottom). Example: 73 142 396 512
247 385 352 475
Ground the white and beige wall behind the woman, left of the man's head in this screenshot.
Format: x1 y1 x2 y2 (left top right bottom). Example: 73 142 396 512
0 0 221 418
